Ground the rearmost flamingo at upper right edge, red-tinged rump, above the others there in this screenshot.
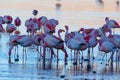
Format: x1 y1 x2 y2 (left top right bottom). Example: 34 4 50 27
105 17 120 33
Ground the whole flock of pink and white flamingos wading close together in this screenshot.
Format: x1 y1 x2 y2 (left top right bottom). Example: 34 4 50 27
0 10 120 63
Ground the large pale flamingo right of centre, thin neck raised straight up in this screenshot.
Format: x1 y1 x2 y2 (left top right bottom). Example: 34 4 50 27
65 26 86 63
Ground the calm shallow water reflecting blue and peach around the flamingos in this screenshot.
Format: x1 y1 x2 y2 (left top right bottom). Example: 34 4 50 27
0 0 120 80
